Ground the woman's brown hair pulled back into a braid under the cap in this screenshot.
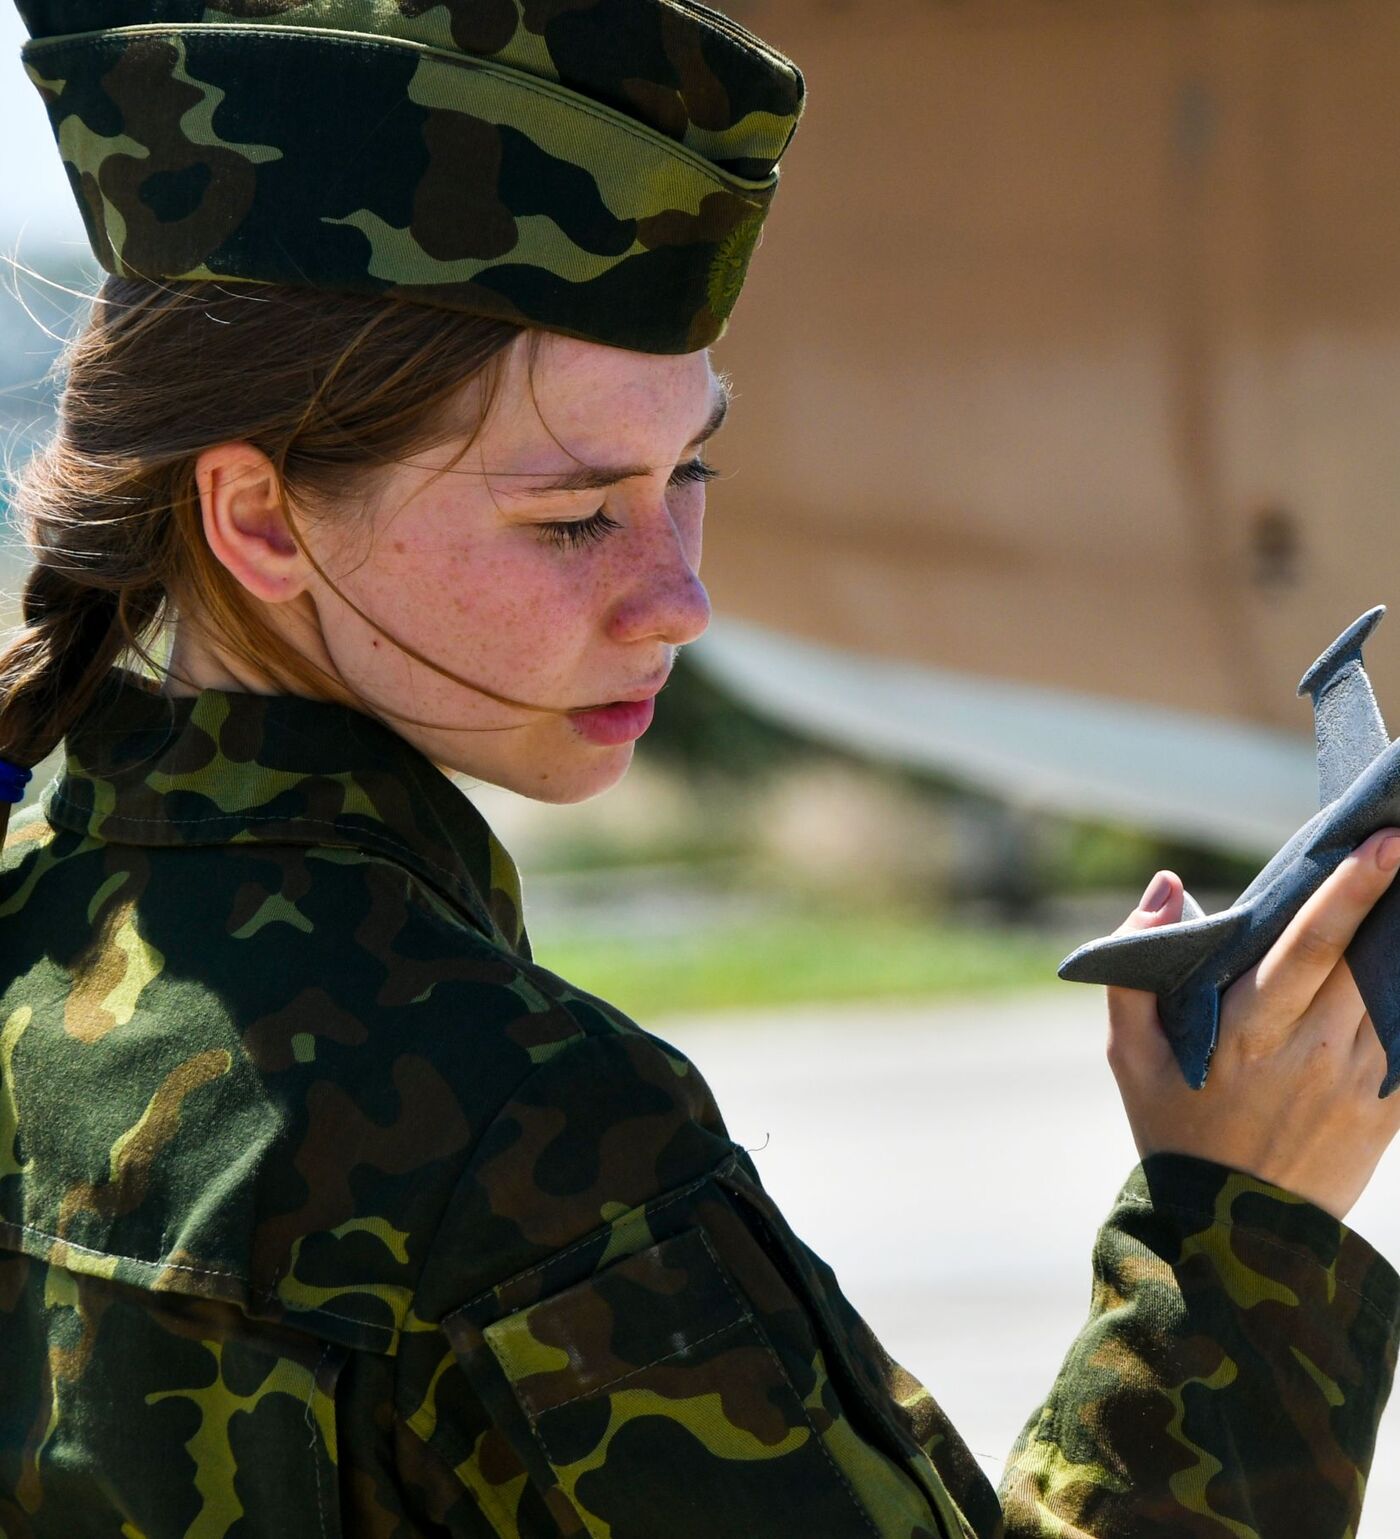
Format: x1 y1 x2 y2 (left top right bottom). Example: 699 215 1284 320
0 277 535 836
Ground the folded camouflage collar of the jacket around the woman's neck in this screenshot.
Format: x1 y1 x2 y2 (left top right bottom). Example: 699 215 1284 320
45 668 529 956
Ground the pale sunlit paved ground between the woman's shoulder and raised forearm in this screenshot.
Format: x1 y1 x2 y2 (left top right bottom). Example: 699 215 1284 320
652 986 1400 1539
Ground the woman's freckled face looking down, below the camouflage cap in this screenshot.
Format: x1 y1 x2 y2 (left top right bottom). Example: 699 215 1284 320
289 334 726 802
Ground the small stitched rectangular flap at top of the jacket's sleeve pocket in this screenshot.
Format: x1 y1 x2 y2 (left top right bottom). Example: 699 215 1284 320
485 1230 748 1419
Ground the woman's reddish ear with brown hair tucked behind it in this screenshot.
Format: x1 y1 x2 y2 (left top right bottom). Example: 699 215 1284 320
194 442 312 603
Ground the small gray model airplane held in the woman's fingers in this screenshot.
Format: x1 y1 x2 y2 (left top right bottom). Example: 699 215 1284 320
1060 605 1400 1096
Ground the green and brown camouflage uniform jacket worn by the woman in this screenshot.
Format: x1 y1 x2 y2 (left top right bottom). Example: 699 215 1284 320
0 671 1400 1539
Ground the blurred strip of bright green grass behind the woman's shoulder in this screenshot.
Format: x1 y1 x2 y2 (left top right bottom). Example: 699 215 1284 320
535 914 1065 1023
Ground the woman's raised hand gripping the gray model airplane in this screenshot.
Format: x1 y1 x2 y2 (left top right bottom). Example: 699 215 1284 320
1108 828 1400 1219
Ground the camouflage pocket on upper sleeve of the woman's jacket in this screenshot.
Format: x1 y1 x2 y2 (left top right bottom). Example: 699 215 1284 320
443 1183 963 1539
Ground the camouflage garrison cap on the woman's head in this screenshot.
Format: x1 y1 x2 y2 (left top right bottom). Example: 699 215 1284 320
10 0 803 352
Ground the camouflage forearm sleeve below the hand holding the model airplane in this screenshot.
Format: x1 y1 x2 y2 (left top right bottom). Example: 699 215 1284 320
1002 1154 1400 1539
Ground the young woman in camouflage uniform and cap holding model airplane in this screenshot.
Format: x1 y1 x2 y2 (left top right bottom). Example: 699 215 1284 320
8 0 1400 1539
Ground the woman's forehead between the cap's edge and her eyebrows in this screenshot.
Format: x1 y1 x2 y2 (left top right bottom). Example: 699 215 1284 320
477 332 720 469
